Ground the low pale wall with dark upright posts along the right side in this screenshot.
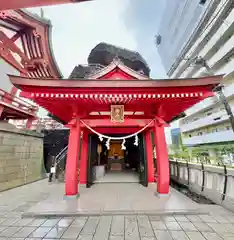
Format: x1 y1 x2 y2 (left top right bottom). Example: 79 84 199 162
170 161 234 211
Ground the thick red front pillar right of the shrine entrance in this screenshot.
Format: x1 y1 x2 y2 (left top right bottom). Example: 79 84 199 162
154 120 170 194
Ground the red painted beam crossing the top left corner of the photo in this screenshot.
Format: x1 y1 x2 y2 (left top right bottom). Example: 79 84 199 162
0 0 90 11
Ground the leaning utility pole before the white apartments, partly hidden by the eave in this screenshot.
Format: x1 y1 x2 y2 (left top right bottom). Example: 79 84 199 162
193 57 234 132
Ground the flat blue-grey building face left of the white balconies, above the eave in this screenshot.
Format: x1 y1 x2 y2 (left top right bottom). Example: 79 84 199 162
156 0 214 73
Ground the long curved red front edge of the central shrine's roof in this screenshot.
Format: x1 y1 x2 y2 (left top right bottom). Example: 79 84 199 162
8 75 223 90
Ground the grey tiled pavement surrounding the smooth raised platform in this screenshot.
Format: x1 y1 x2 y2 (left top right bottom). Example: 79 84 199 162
0 181 234 240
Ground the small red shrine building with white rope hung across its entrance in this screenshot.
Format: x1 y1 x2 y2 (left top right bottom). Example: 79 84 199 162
9 54 222 197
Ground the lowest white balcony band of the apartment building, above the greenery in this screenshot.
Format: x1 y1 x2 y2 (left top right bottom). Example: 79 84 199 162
183 130 234 145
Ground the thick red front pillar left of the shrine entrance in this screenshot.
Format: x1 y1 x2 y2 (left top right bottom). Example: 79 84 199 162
65 119 80 197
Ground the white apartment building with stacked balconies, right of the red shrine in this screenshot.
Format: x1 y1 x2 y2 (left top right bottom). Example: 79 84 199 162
158 0 234 146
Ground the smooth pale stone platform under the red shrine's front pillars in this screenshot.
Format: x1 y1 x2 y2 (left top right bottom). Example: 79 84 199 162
20 181 218 217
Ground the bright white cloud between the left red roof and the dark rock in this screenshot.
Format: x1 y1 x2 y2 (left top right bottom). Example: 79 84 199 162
30 0 137 77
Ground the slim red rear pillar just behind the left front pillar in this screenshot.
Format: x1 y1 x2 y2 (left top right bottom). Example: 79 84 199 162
80 130 88 184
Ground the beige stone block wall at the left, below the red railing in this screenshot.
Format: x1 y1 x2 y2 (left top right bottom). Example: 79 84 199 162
0 122 45 191
